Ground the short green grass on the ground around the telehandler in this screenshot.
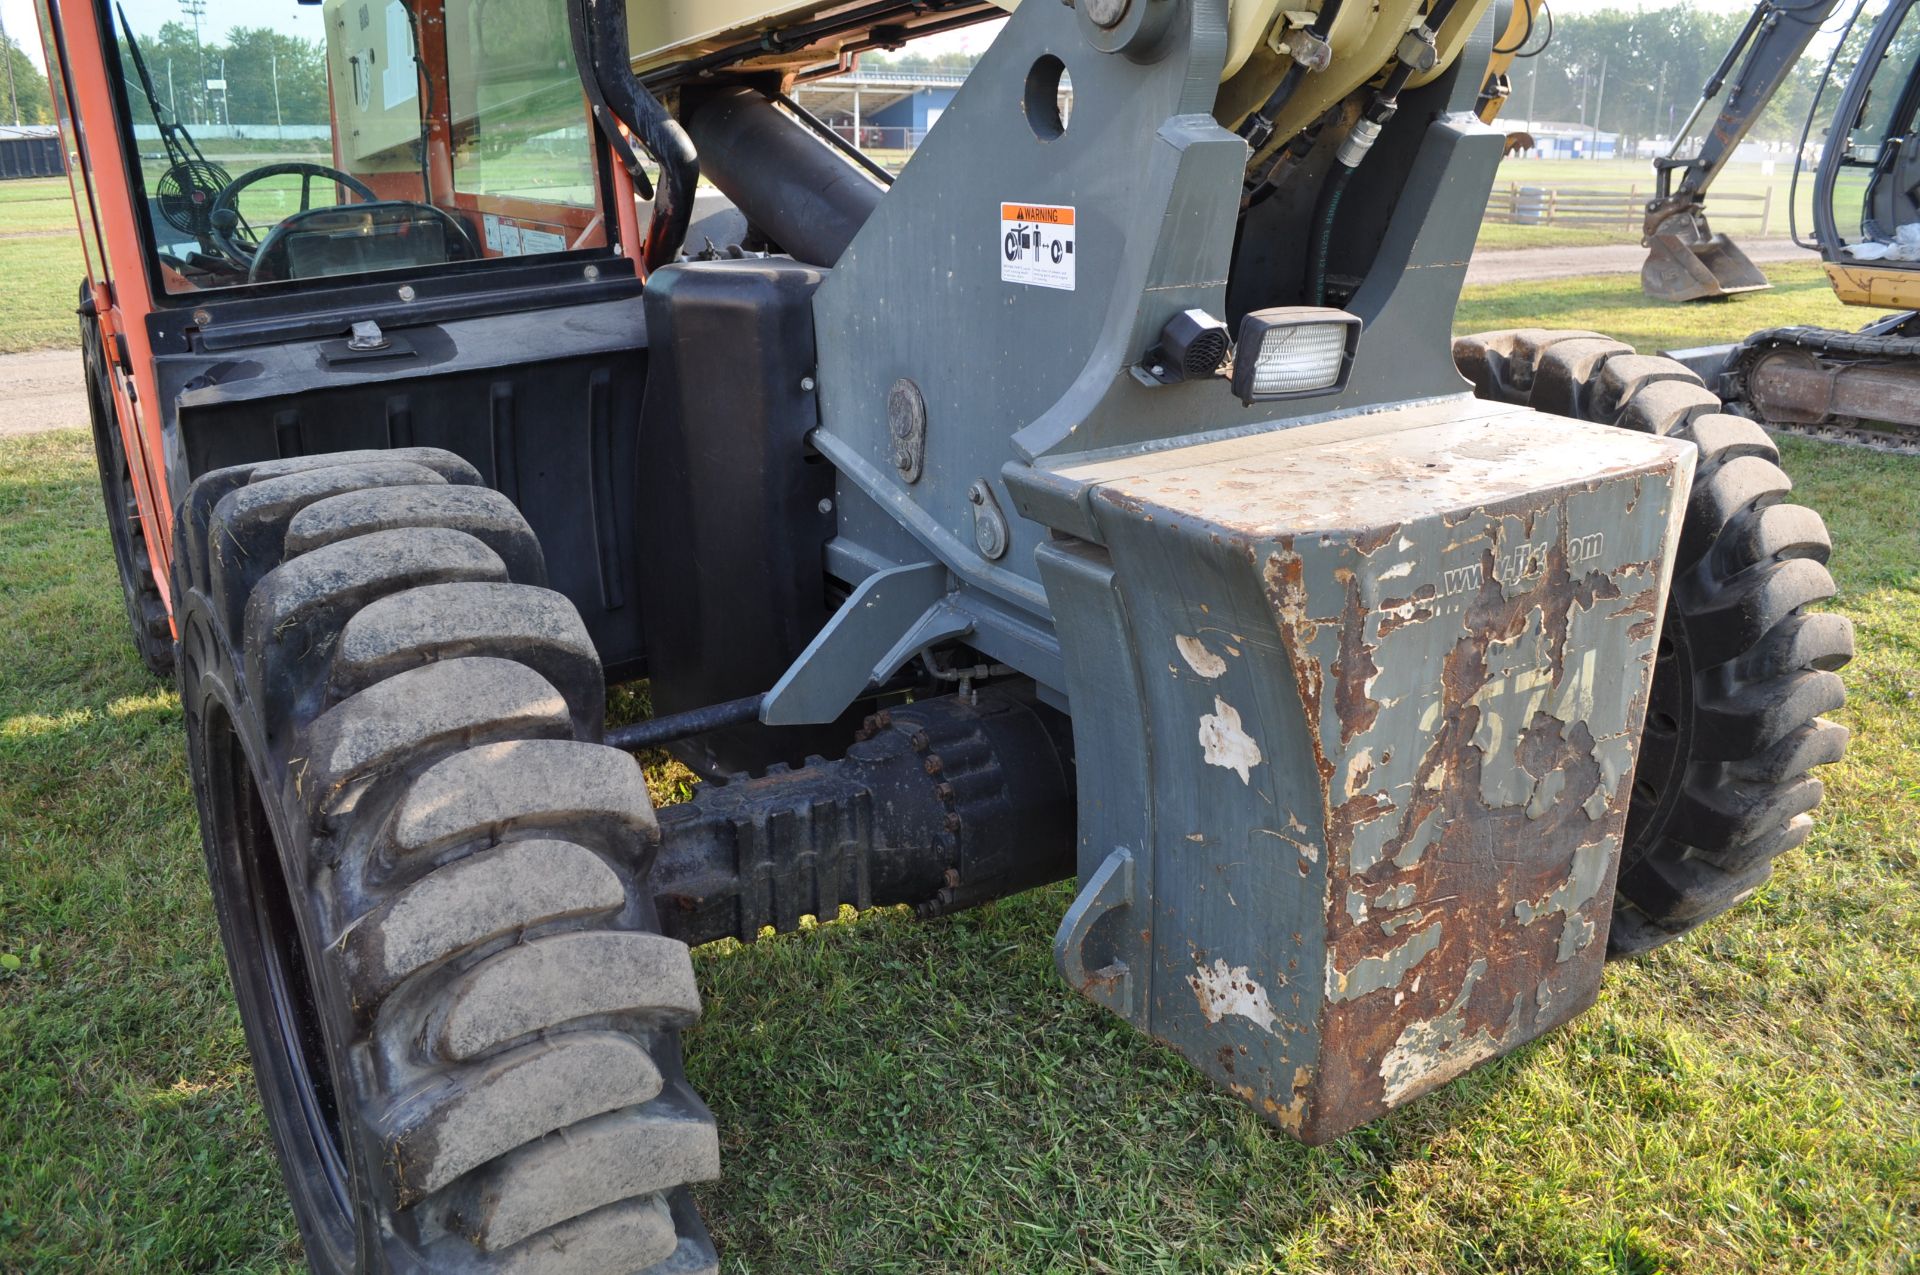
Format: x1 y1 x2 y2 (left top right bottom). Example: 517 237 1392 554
0 171 1920 1275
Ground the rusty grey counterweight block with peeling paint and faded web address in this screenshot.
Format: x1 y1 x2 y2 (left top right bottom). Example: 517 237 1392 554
1043 399 1693 1143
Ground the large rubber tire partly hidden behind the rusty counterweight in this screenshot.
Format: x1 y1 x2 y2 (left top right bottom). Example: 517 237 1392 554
1453 328 1853 956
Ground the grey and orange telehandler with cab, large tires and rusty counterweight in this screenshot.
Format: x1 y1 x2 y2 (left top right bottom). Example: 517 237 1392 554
36 0 1851 1275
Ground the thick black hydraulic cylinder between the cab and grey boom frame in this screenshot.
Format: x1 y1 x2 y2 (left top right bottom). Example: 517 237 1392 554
687 88 885 265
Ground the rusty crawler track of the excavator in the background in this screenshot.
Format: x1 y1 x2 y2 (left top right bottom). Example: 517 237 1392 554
1718 315 1920 455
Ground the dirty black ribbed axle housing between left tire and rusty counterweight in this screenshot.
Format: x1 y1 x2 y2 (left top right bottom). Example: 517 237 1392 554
651 689 1075 943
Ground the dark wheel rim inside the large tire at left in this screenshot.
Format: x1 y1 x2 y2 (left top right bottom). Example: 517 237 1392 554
205 709 353 1254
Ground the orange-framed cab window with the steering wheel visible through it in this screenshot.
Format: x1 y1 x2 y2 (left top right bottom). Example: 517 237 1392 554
113 0 607 292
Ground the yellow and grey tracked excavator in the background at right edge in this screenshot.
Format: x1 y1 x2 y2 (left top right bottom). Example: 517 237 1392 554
1642 0 1920 451
